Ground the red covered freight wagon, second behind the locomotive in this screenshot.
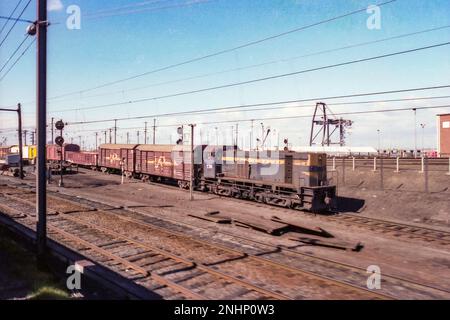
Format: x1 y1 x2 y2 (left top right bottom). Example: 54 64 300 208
98 144 138 174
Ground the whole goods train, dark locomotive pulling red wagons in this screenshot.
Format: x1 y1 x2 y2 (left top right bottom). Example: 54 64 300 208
0 144 336 212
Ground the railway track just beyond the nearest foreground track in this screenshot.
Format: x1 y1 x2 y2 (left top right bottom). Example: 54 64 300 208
2 184 450 299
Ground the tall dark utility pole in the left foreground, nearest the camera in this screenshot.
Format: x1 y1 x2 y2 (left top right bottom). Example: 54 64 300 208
34 0 48 258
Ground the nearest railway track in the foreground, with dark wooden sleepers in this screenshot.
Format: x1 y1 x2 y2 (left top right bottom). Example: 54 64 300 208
3 185 391 299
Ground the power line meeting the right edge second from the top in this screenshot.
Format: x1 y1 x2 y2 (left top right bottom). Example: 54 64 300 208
56 42 450 113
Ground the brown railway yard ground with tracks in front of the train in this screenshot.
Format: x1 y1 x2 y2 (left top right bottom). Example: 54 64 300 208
0 165 450 300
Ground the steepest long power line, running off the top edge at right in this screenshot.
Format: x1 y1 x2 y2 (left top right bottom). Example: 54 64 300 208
46 0 397 98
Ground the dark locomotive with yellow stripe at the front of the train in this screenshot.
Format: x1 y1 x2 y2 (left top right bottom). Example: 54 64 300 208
203 148 336 211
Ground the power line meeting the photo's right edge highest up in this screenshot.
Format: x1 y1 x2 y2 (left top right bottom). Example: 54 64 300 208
44 25 450 102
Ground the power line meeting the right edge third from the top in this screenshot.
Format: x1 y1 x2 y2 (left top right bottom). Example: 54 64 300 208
69 84 450 125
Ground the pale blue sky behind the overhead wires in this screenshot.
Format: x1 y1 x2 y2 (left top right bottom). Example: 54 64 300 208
0 0 450 148
